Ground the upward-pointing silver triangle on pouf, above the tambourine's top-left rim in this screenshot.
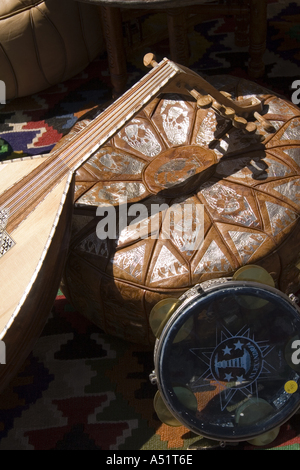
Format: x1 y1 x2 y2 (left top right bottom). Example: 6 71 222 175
194 241 232 274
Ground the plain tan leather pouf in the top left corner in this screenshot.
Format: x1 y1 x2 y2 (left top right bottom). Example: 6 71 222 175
0 0 104 99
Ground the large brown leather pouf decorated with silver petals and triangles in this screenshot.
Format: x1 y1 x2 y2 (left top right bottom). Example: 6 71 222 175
62 76 300 344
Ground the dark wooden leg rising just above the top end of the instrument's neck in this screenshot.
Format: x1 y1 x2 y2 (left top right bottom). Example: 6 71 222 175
167 8 189 65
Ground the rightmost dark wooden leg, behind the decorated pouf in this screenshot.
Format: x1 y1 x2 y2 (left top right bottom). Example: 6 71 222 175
248 0 267 78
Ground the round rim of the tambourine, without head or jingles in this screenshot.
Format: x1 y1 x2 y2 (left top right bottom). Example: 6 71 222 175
154 278 300 442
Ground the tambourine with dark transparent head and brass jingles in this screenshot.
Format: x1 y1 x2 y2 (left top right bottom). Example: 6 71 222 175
150 266 300 446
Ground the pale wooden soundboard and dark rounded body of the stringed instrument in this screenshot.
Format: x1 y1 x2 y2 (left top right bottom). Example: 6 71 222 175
0 157 74 390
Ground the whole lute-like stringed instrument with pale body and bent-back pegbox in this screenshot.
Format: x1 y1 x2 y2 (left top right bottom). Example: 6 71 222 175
0 54 262 391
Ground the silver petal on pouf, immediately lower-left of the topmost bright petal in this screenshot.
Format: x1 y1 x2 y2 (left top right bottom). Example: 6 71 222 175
118 119 161 157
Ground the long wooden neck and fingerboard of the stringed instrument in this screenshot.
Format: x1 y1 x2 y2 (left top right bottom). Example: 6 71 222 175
0 59 181 233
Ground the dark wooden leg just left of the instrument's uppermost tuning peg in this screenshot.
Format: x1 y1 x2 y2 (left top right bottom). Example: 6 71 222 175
100 6 127 98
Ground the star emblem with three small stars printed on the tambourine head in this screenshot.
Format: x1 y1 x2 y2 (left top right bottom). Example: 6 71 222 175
190 326 274 411
